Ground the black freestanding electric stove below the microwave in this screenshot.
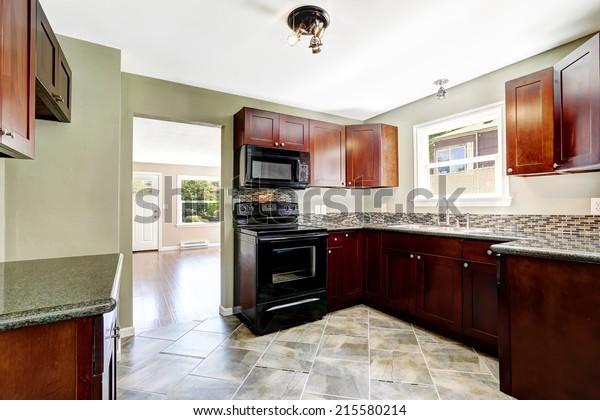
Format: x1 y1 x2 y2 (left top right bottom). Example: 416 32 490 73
233 202 328 334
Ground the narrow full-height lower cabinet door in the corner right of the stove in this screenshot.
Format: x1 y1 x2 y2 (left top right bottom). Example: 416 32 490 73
342 232 363 302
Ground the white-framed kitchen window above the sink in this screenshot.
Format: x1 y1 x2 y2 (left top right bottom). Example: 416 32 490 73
414 104 510 206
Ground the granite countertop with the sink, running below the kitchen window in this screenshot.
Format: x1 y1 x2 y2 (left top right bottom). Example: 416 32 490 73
304 223 600 264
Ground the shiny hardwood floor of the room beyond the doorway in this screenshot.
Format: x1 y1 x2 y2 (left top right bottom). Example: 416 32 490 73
133 248 221 332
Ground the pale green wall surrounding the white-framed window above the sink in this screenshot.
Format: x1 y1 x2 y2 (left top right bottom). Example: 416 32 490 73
365 34 600 214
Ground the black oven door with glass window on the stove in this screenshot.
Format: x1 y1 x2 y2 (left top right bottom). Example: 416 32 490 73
256 233 328 302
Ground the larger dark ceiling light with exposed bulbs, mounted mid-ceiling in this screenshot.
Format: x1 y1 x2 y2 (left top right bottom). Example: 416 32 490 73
288 6 329 54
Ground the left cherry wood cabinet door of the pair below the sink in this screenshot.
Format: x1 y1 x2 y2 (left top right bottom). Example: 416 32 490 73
380 247 416 315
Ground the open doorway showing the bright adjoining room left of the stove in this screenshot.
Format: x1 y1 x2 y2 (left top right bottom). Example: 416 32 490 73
132 116 222 332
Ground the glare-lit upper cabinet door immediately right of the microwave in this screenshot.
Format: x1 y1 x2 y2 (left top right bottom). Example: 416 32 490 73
309 121 346 188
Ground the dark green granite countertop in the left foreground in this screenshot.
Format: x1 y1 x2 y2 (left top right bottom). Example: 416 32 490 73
0 254 123 331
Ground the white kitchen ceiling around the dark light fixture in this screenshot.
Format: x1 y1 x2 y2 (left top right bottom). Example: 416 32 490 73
42 0 600 120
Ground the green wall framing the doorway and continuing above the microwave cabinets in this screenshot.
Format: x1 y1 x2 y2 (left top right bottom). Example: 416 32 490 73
120 73 358 326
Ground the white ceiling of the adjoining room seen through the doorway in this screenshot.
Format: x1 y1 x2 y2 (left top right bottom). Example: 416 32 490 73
133 117 221 167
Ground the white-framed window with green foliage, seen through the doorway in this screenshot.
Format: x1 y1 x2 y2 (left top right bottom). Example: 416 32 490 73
177 175 220 226
